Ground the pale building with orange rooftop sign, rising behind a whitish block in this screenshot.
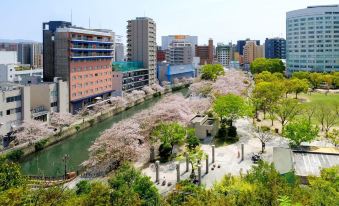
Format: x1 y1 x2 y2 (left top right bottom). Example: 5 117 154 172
161 35 198 56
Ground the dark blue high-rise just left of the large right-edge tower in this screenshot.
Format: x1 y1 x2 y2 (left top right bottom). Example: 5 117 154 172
265 37 286 59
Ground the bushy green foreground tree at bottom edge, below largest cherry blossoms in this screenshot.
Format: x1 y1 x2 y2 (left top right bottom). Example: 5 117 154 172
108 164 160 206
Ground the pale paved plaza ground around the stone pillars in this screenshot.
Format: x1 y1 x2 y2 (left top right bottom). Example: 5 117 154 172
143 119 288 193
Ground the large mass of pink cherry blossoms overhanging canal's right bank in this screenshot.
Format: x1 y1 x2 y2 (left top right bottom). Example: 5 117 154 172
84 94 207 171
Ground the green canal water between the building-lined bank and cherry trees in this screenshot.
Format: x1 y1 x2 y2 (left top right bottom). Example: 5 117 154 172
20 89 188 176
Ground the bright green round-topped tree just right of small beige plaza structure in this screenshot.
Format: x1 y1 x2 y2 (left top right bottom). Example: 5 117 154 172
213 94 250 126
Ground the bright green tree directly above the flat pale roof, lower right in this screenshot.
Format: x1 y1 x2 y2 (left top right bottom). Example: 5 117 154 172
283 119 319 147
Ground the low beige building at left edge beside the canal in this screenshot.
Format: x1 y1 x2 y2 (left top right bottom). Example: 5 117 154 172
0 79 69 135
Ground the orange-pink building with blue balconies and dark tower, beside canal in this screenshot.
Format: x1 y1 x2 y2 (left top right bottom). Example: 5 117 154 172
43 21 115 113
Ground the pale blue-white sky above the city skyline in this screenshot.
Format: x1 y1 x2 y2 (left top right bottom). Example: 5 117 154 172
0 0 339 44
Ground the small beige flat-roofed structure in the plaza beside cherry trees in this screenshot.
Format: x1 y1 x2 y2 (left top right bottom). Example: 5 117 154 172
189 115 218 140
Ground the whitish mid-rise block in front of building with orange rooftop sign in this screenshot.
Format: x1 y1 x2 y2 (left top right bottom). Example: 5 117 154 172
166 41 193 65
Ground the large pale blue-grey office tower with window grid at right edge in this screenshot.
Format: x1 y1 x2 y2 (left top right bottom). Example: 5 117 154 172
286 5 339 73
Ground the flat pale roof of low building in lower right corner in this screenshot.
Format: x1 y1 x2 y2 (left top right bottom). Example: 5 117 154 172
273 146 339 176
